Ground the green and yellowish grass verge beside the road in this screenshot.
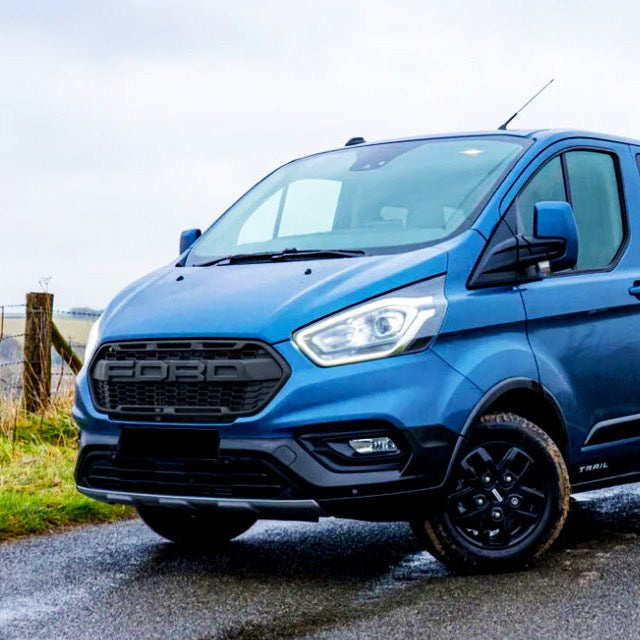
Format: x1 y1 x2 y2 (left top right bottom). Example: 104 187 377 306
0 392 133 541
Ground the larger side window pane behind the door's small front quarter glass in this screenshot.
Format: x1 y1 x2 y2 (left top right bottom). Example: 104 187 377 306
565 151 624 269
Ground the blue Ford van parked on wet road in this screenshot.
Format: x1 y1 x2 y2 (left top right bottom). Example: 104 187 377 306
73 131 640 571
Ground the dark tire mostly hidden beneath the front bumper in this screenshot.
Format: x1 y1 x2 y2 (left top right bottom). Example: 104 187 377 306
137 507 256 547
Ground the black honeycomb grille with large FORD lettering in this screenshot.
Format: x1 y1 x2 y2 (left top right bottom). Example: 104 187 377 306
89 340 289 422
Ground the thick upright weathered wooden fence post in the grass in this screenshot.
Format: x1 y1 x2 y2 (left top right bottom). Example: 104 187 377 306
23 293 53 413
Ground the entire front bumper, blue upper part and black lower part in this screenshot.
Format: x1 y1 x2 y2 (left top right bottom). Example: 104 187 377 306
73 342 481 521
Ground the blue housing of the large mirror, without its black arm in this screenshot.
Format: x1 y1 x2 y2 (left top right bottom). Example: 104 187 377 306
533 201 578 271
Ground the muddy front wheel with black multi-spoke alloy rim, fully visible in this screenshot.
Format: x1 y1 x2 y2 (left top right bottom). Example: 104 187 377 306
414 413 570 572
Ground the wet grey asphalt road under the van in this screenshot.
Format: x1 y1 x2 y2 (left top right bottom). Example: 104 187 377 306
0 485 640 640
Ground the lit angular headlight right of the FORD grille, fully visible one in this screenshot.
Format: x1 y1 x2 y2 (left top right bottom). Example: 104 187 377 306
293 276 447 367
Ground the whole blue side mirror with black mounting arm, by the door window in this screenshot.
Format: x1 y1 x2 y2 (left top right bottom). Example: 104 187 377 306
469 201 578 287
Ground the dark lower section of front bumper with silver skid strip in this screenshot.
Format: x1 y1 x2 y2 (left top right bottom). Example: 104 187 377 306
76 427 459 521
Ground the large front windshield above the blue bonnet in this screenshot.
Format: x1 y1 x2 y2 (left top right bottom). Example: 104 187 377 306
187 136 524 265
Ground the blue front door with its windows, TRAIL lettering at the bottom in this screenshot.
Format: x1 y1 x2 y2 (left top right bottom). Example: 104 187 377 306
498 141 640 484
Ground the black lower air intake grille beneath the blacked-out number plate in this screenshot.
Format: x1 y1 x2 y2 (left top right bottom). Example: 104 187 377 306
77 450 298 500
